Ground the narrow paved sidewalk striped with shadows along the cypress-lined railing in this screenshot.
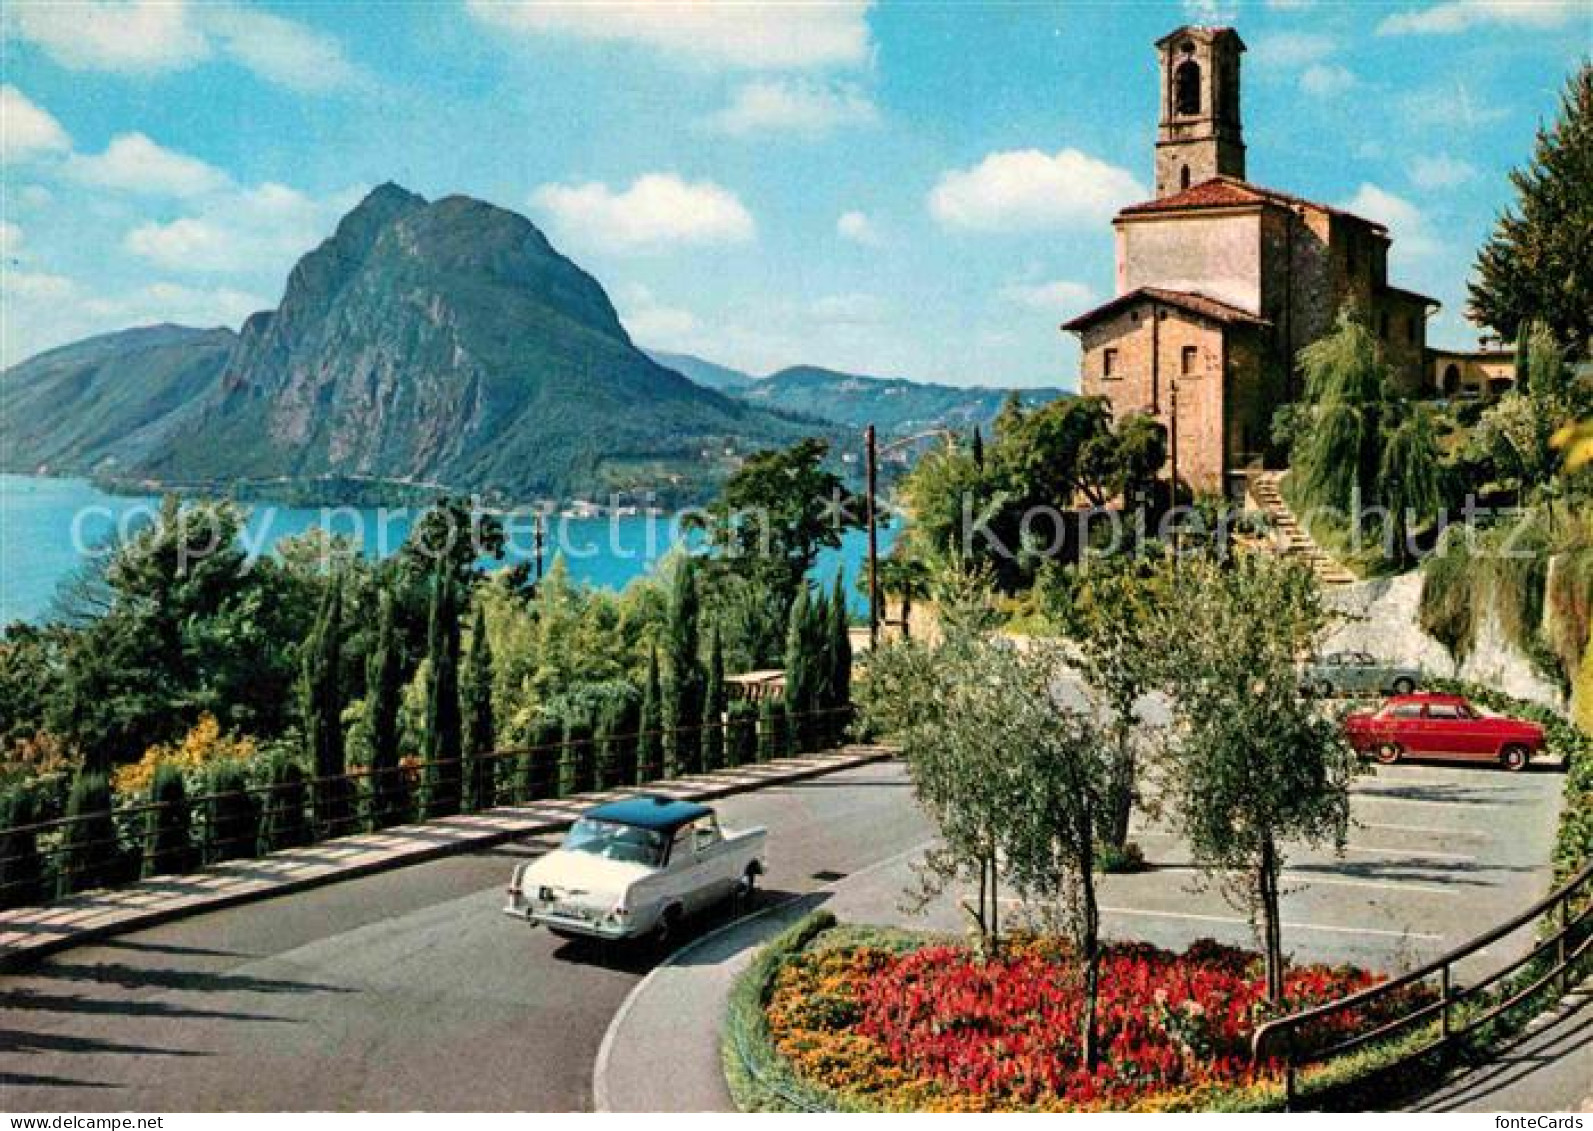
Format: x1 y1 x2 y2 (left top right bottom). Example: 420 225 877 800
0 746 892 970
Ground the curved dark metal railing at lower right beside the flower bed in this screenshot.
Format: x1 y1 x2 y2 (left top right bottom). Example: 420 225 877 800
1251 860 1593 1107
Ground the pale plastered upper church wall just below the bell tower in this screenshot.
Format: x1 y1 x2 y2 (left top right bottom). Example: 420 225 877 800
1117 210 1262 311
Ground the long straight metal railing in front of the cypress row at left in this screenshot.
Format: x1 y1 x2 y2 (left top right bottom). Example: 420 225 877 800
0 706 852 908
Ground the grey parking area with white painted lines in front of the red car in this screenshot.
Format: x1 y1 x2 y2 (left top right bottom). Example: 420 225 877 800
830 763 1564 970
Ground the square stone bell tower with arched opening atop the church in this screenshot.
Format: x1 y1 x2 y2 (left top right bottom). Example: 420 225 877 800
1157 25 1244 199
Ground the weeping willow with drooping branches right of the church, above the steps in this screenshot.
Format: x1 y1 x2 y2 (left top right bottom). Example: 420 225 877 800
1290 304 1389 522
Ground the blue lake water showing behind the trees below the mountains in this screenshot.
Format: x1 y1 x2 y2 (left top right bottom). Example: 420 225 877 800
0 475 895 624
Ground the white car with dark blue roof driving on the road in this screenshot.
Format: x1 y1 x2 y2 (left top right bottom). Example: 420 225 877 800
503 795 766 940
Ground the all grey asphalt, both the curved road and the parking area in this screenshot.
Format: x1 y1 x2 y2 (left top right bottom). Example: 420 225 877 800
0 763 1561 1110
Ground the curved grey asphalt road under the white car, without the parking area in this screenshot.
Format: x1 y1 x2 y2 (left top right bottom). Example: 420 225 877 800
0 763 929 1112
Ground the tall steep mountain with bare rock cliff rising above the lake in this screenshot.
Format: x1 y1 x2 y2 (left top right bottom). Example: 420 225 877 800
140 185 800 499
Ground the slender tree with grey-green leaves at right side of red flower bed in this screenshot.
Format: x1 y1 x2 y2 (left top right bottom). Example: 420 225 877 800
1168 556 1356 1005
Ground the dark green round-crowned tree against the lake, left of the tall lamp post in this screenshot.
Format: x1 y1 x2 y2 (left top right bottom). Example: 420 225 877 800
698 438 862 621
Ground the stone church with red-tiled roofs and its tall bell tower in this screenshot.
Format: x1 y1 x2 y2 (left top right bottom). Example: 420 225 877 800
1063 27 1438 495
